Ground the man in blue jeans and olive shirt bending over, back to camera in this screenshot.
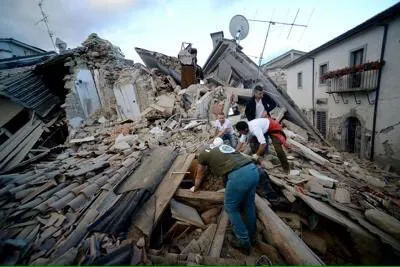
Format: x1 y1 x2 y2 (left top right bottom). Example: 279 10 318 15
193 138 259 255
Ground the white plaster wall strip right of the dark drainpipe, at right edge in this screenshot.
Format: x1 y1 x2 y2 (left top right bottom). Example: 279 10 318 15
375 18 400 170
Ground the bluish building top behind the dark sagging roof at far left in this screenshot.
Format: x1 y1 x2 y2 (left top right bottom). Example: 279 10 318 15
0 38 46 59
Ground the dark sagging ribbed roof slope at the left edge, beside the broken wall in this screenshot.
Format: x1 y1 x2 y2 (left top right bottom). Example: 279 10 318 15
0 70 60 117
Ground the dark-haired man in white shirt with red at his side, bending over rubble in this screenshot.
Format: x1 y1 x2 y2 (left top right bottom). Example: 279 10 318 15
236 118 290 173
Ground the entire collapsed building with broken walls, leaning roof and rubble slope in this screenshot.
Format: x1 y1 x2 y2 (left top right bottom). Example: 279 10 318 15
0 34 400 265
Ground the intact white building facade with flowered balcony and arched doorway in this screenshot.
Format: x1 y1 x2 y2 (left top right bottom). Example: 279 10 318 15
285 3 400 172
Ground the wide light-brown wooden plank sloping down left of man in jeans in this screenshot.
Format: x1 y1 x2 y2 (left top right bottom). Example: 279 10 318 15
133 154 195 236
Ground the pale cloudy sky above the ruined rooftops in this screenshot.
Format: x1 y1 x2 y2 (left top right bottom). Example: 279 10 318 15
0 0 398 65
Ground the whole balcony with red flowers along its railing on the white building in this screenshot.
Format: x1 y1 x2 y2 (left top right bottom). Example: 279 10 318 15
322 62 383 94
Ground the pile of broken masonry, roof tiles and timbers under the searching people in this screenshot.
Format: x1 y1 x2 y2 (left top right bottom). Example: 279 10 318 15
0 33 400 265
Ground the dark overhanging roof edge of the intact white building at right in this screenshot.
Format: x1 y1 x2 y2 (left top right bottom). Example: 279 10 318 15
284 2 400 68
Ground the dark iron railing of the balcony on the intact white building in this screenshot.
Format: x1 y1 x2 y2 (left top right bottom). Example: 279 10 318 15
325 69 380 94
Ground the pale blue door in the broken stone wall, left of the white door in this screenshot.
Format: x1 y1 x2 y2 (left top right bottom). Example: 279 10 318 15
75 69 101 118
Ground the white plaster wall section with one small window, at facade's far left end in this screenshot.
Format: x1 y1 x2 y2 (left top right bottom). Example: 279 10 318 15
286 59 312 110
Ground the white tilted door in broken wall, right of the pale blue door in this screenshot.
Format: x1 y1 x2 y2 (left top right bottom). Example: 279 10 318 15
114 84 140 120
